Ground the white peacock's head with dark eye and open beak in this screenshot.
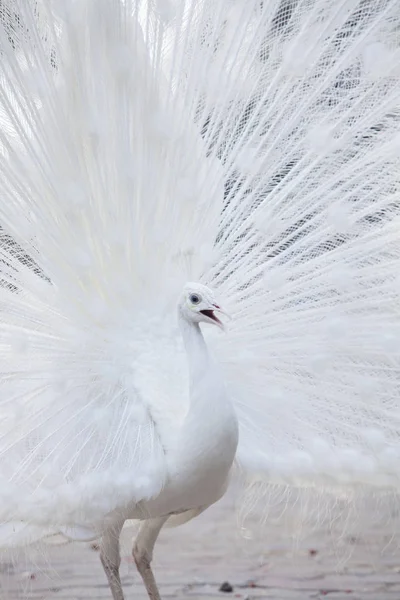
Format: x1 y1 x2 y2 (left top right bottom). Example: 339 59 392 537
179 283 225 329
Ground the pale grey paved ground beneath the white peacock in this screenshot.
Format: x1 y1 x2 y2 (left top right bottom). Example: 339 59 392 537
0 492 400 600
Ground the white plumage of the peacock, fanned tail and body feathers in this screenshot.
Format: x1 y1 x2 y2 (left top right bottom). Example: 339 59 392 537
0 0 400 600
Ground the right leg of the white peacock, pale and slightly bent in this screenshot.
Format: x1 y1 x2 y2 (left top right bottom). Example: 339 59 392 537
132 517 168 600
